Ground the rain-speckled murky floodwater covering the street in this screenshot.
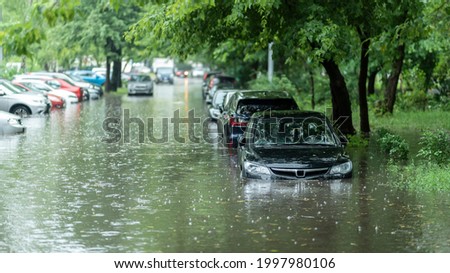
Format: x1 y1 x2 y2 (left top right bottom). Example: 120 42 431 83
0 79 450 253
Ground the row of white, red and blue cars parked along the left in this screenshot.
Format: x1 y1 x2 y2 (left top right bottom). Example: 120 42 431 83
0 72 103 135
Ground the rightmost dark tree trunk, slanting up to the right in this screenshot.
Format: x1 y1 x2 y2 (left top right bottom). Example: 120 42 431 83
384 44 405 114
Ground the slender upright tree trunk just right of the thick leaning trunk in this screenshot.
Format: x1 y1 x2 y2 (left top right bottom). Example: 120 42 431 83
358 35 370 135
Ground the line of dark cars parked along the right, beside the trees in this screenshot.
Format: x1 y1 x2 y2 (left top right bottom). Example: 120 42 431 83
202 72 353 179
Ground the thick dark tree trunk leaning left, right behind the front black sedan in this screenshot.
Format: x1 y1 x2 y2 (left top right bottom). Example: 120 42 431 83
321 60 355 135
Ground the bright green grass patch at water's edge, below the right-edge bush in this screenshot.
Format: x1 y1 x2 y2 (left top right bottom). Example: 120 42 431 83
387 162 450 192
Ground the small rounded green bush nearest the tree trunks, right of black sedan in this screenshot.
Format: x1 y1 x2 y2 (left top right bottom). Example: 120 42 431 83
376 128 409 159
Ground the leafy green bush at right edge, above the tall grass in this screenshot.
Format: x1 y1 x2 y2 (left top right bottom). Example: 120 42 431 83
417 130 450 165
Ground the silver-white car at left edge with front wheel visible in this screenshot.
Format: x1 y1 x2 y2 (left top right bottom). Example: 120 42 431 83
0 80 51 117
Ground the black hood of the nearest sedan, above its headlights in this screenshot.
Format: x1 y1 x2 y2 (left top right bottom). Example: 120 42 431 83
248 146 347 168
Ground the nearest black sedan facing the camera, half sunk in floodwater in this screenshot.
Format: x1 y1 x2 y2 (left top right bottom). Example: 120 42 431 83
238 111 353 179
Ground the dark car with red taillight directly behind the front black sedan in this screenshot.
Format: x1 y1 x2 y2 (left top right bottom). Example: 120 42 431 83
217 90 298 147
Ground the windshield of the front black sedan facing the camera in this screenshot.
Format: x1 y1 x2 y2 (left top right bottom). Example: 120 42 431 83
251 117 337 146
